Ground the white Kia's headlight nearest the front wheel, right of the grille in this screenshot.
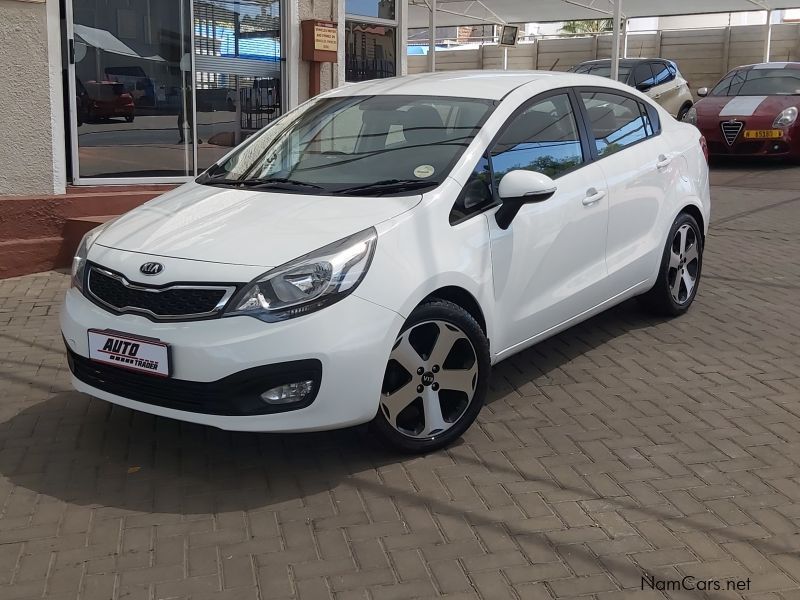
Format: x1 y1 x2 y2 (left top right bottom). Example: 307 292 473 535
225 228 378 322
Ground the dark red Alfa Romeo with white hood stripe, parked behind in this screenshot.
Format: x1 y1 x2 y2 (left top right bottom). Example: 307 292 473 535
684 62 800 161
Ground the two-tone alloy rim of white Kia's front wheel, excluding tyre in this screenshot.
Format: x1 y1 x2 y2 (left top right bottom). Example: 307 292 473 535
381 320 478 439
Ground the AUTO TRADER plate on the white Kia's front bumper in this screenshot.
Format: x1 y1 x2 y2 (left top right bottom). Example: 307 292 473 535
89 329 169 377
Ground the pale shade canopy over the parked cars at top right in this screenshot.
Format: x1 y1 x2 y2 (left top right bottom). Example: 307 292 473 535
409 0 800 27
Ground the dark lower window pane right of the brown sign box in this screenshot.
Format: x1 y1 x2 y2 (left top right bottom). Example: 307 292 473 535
345 21 397 81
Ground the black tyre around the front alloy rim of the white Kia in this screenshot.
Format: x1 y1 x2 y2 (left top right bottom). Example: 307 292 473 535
370 299 491 454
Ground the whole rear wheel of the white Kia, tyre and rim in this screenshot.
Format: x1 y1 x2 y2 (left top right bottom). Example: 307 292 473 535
639 213 703 316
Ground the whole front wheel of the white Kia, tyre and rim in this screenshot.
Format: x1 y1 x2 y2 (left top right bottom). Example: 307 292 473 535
371 300 491 454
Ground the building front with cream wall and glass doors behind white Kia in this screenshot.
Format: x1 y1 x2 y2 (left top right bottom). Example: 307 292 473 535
0 0 405 196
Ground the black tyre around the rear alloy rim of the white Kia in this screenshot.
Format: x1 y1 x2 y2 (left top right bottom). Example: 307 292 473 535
639 213 703 317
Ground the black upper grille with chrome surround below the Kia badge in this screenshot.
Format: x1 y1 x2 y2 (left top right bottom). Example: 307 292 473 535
86 265 236 320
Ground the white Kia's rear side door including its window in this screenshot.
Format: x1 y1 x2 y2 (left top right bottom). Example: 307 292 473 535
578 88 678 296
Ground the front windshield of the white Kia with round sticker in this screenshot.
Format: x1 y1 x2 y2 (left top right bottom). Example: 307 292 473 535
198 95 495 196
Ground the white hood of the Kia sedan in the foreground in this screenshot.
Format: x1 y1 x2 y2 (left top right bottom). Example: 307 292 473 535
95 183 421 268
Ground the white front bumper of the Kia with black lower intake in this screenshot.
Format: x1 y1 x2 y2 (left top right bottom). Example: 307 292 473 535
61 288 403 432
